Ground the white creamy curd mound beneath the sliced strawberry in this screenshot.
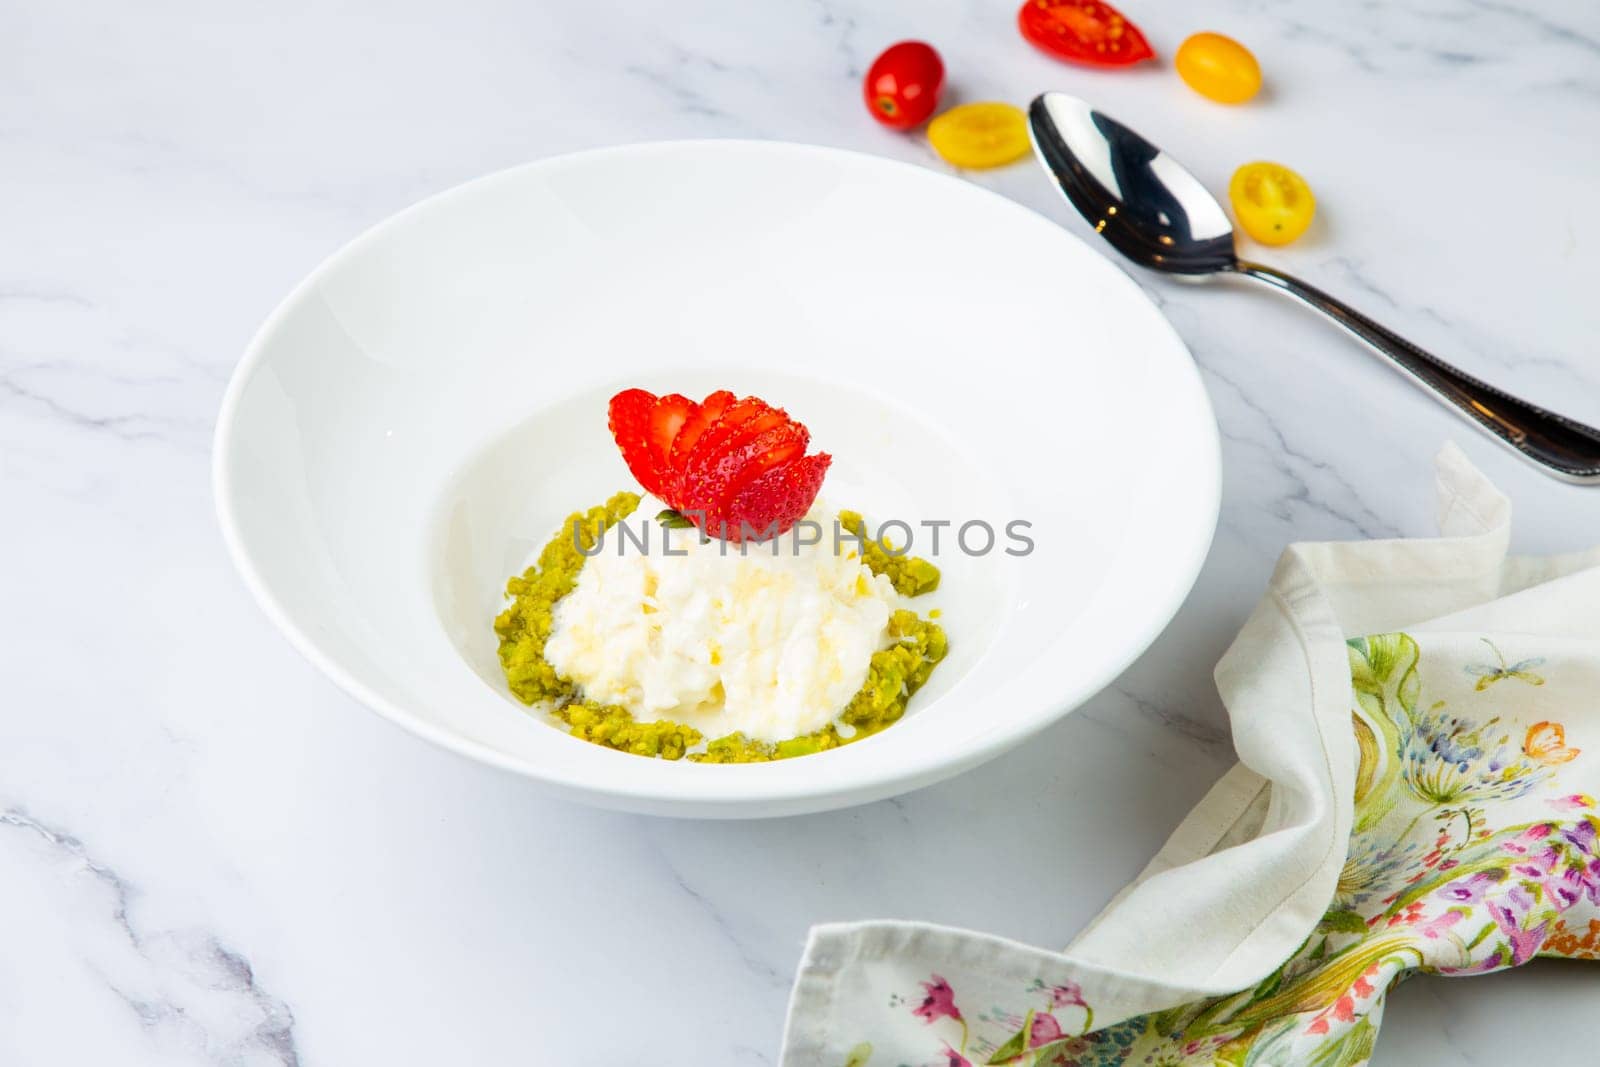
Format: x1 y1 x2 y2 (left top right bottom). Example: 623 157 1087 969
544 498 899 741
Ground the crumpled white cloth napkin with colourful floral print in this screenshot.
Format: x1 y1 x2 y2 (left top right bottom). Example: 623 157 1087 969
781 446 1600 1067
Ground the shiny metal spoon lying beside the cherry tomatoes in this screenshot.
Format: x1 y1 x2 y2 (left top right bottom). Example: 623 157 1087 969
1027 93 1600 485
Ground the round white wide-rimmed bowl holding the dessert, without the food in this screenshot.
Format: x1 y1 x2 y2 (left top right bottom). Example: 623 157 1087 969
214 141 1219 817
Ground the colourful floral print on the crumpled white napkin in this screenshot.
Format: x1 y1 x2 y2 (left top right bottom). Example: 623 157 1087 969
848 633 1600 1067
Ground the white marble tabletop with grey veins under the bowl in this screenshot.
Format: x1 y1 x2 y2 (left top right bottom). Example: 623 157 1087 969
0 0 1600 1067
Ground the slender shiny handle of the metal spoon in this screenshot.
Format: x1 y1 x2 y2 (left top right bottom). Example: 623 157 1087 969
1235 259 1600 485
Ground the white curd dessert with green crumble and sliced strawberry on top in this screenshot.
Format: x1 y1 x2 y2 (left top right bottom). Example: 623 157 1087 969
494 390 946 763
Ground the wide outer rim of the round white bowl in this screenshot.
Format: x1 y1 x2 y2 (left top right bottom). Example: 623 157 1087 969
210 138 1222 817
